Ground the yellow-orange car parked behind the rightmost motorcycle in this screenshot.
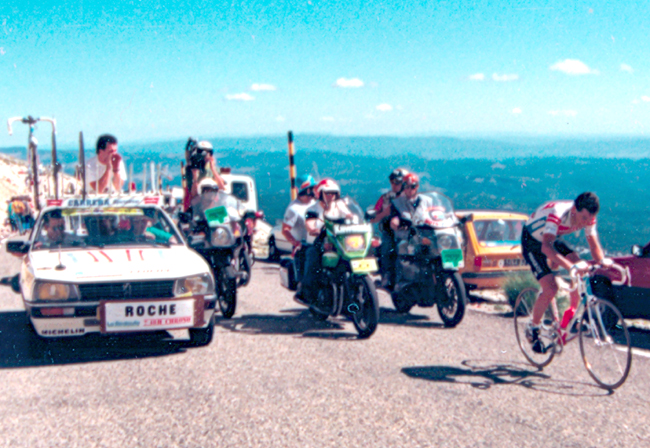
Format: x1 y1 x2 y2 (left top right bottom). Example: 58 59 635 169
456 210 529 289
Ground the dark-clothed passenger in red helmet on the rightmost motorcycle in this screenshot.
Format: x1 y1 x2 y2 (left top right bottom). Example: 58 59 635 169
370 168 408 290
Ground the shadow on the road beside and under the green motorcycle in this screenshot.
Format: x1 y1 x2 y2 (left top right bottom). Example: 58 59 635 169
215 308 357 339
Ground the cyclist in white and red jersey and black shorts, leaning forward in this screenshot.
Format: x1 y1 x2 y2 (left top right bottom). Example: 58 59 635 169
521 192 604 353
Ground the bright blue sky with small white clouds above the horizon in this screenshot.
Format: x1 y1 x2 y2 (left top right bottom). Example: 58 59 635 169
0 0 650 147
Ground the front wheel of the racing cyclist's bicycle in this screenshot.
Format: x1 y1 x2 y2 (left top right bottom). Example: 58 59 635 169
579 299 632 390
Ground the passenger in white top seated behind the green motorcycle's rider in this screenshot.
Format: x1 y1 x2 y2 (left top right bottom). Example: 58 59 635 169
282 174 316 282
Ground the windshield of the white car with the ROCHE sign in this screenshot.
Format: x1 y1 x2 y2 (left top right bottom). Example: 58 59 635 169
33 207 183 250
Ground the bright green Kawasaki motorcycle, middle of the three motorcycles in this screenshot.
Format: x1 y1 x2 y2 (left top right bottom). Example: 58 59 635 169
280 197 379 338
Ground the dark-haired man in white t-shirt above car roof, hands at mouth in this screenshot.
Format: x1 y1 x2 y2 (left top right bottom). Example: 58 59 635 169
86 134 126 193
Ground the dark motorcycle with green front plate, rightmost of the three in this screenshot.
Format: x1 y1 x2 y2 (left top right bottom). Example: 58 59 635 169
382 192 467 327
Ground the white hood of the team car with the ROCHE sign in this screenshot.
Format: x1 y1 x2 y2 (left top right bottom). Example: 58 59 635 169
30 246 210 283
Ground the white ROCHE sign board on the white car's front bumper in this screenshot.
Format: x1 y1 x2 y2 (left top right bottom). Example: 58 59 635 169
100 298 195 333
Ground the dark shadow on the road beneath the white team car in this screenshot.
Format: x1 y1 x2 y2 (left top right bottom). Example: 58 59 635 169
0 311 186 369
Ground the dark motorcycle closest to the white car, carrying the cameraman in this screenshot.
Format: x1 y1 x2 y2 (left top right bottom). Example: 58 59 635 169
181 192 252 319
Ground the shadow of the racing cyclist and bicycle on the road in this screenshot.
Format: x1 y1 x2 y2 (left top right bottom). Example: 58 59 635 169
402 360 613 397
